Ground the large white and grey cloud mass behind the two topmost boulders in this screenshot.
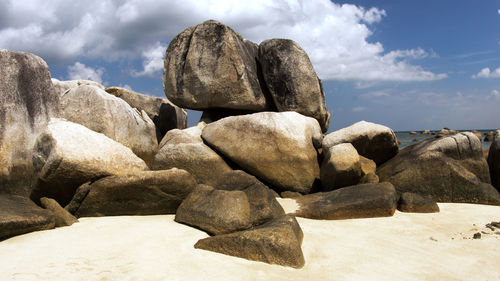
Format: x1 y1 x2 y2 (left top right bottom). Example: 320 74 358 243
0 0 446 81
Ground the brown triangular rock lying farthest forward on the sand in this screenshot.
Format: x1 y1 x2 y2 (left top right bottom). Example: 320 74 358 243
194 216 305 268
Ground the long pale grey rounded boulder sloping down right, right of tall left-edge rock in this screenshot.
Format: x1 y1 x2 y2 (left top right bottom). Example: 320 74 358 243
61 85 158 165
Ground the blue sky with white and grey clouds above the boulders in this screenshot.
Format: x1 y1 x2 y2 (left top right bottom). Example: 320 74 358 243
0 0 500 132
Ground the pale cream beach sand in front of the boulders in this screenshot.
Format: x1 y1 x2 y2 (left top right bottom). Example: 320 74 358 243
0 200 500 280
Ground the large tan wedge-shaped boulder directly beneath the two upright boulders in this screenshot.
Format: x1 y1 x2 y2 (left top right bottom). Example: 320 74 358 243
202 112 322 193
